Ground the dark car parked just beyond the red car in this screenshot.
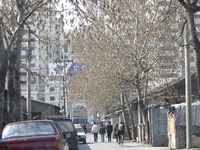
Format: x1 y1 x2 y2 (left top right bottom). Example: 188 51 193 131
47 117 79 150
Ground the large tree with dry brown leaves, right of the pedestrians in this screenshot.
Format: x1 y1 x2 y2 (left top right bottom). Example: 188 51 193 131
68 0 182 141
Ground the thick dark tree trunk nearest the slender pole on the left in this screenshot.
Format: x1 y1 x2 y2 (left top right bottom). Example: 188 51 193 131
8 23 23 122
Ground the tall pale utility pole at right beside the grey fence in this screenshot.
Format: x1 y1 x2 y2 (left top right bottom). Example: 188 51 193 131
184 23 192 149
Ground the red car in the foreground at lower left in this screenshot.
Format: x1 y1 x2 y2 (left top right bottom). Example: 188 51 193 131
0 120 69 150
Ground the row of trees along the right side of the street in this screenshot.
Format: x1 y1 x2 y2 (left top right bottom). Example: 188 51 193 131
66 0 200 142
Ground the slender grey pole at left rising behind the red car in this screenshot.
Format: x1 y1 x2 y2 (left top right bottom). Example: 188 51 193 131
26 27 32 120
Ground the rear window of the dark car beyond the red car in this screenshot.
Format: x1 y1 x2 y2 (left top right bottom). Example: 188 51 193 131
56 120 74 132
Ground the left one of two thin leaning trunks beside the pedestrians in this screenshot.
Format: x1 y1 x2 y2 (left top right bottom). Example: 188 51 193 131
121 93 131 140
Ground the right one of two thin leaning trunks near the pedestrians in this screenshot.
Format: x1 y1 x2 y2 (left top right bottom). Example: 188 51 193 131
124 93 136 141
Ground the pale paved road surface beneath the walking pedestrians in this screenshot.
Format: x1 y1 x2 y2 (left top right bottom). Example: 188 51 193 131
79 134 169 150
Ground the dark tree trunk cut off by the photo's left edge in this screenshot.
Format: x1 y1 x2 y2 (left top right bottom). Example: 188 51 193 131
0 20 8 131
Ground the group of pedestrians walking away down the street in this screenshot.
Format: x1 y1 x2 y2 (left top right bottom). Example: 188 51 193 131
92 121 125 143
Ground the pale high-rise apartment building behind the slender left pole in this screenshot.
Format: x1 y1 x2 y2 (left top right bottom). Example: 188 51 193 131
20 12 63 102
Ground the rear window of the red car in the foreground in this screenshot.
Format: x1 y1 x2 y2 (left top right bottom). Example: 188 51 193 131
2 122 55 139
